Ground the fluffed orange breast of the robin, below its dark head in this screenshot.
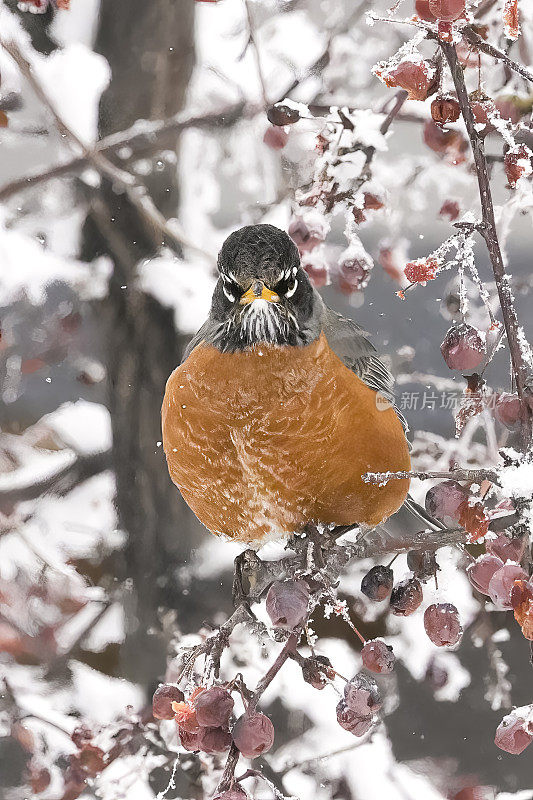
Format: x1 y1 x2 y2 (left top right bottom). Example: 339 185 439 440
162 334 410 543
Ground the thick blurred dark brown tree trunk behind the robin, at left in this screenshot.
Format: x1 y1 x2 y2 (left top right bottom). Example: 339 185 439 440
85 0 199 684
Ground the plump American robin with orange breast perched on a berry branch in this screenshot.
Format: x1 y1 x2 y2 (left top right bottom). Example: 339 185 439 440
162 225 410 547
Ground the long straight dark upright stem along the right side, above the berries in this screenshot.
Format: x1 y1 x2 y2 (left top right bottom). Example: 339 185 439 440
439 40 532 449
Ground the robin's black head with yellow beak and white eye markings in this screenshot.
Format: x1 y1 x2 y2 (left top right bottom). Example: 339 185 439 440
211 225 319 350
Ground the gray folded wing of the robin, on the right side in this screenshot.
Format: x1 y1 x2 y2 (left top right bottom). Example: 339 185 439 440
321 296 408 431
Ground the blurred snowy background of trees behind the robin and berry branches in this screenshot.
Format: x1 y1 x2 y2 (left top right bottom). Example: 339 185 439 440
0 0 533 800
